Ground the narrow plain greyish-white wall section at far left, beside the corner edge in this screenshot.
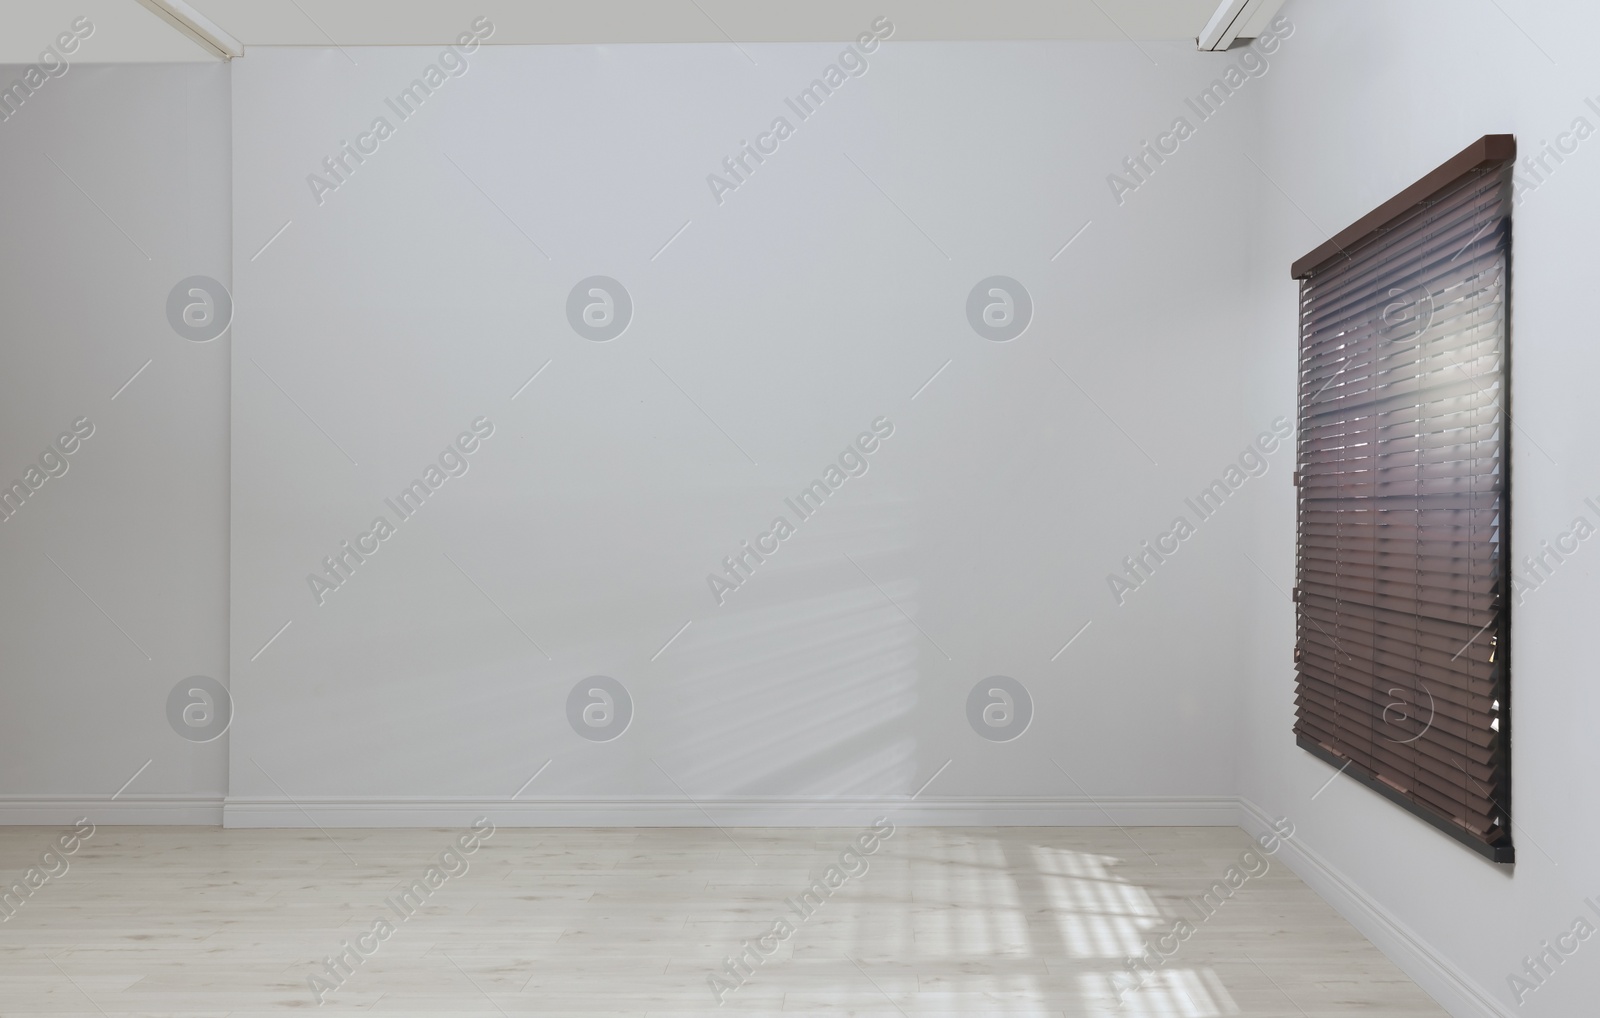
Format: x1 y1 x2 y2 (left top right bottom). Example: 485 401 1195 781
0 61 230 823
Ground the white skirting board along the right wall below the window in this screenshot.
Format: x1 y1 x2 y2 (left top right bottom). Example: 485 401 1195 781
1238 799 1512 1018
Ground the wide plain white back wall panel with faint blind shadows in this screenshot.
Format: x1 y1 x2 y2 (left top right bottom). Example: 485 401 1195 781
229 35 1273 823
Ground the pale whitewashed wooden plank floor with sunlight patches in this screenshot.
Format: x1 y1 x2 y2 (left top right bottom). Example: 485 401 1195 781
0 826 1445 1018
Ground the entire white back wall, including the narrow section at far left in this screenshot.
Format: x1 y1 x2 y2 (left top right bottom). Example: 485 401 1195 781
0 35 1266 824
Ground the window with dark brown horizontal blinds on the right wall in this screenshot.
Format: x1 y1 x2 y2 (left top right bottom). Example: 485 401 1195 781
1293 134 1517 863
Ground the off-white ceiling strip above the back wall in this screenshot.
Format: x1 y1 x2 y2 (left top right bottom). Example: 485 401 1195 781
0 0 1275 64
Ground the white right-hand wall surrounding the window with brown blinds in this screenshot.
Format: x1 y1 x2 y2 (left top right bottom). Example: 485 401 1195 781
1240 0 1600 1016
